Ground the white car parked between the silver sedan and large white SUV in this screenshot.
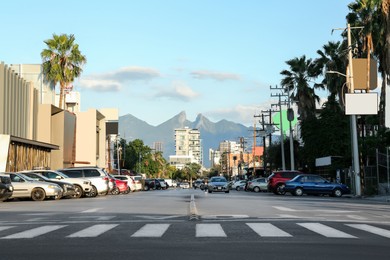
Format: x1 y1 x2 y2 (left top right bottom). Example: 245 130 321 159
30 170 92 198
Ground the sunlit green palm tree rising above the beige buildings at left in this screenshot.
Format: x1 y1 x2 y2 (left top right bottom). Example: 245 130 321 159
41 34 87 108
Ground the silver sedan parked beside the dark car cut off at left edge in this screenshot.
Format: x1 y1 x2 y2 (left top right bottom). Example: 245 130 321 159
6 172 62 201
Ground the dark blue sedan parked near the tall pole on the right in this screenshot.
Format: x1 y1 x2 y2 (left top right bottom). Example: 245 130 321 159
284 174 351 197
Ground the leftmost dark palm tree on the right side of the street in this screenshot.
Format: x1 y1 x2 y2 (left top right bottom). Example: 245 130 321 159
280 55 323 120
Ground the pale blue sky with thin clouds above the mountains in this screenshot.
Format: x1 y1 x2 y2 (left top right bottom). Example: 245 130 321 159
0 0 353 126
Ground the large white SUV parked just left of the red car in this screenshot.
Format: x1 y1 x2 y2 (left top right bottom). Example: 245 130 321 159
58 166 113 197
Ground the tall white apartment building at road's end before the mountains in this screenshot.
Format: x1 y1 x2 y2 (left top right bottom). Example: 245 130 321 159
169 127 203 169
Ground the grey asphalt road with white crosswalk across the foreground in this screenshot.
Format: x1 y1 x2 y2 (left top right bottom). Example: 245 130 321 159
0 189 390 260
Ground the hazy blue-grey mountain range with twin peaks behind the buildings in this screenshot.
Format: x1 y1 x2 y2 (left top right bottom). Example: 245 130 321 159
119 111 253 167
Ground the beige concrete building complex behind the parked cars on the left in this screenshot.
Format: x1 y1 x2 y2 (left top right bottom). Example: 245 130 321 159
0 63 118 172
